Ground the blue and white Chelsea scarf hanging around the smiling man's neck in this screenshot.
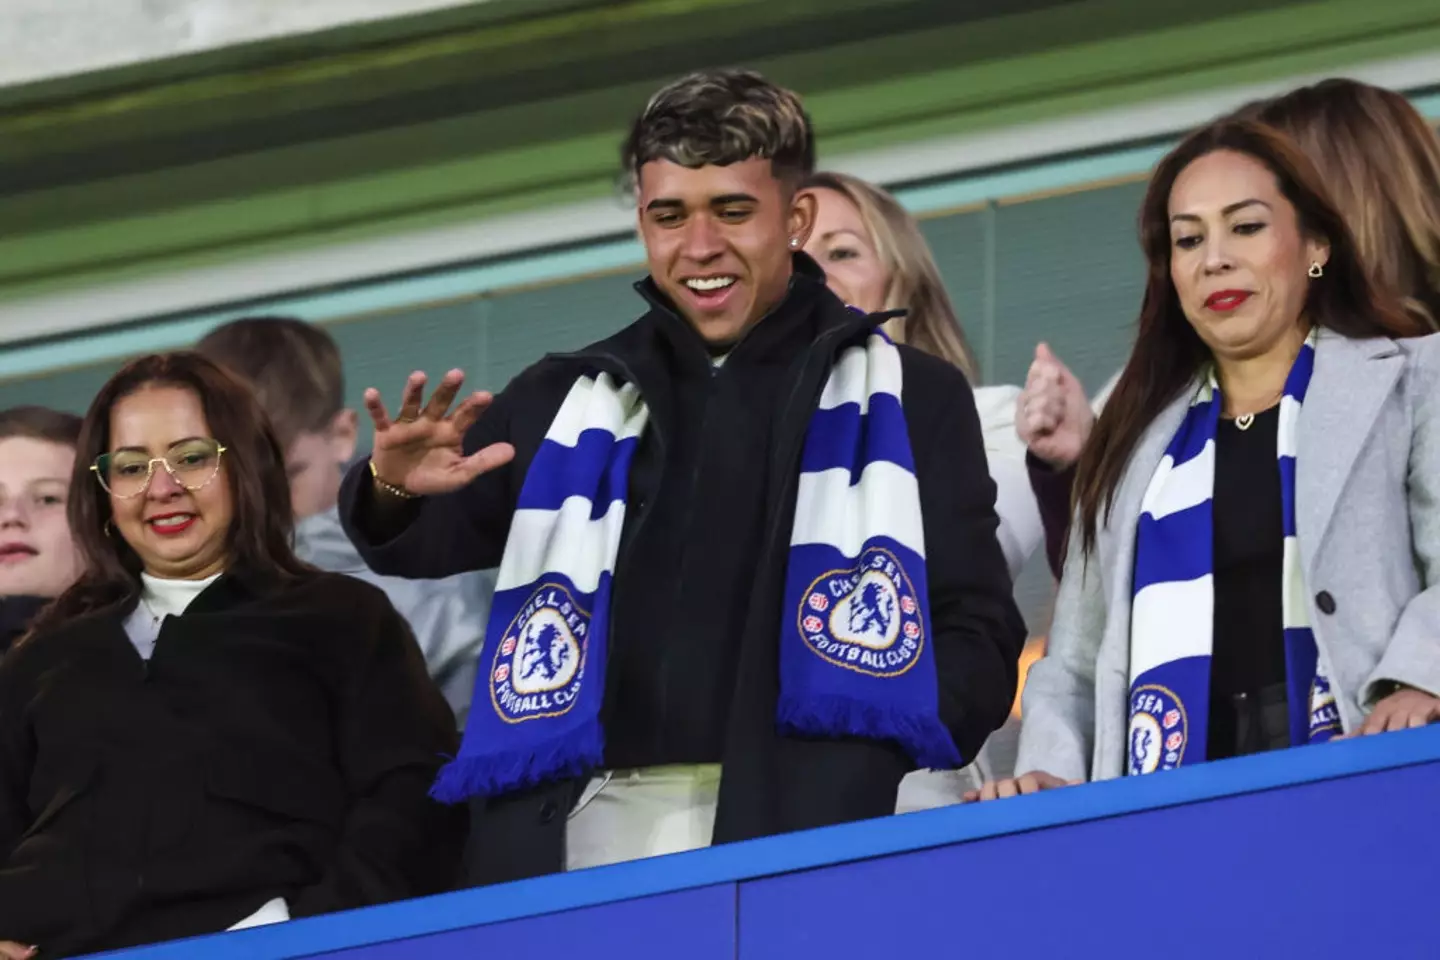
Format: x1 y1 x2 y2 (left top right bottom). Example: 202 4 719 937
432 332 960 802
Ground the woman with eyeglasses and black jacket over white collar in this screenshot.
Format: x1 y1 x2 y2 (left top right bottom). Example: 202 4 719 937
0 353 464 957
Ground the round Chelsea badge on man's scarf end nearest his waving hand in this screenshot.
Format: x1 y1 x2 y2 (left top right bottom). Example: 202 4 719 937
490 583 590 724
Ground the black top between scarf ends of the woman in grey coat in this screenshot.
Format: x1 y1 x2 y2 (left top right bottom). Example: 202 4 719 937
1207 406 1284 759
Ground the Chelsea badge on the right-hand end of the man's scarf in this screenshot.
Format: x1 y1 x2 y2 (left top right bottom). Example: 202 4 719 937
796 547 924 676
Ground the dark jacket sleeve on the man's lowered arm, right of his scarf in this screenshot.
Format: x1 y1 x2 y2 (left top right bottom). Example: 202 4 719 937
906 356 1025 763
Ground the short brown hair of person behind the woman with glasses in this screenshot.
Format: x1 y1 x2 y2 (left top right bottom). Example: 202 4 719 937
196 317 346 448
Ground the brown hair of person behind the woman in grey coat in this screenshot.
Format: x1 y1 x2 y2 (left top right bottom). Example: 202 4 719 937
1236 79 1440 330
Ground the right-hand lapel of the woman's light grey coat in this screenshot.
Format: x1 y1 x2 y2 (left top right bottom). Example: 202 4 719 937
1295 331 1405 574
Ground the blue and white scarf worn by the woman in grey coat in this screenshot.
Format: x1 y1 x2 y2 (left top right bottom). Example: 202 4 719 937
1126 332 1341 774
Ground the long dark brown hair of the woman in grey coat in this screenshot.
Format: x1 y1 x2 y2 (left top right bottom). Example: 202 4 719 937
1076 119 1426 551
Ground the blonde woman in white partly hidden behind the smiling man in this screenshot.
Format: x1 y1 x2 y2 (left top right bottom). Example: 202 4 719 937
805 173 1044 579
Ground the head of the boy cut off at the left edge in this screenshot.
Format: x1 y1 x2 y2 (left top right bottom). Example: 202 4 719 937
0 407 81 653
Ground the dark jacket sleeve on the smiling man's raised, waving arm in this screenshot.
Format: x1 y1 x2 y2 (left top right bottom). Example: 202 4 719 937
340 377 523 579
